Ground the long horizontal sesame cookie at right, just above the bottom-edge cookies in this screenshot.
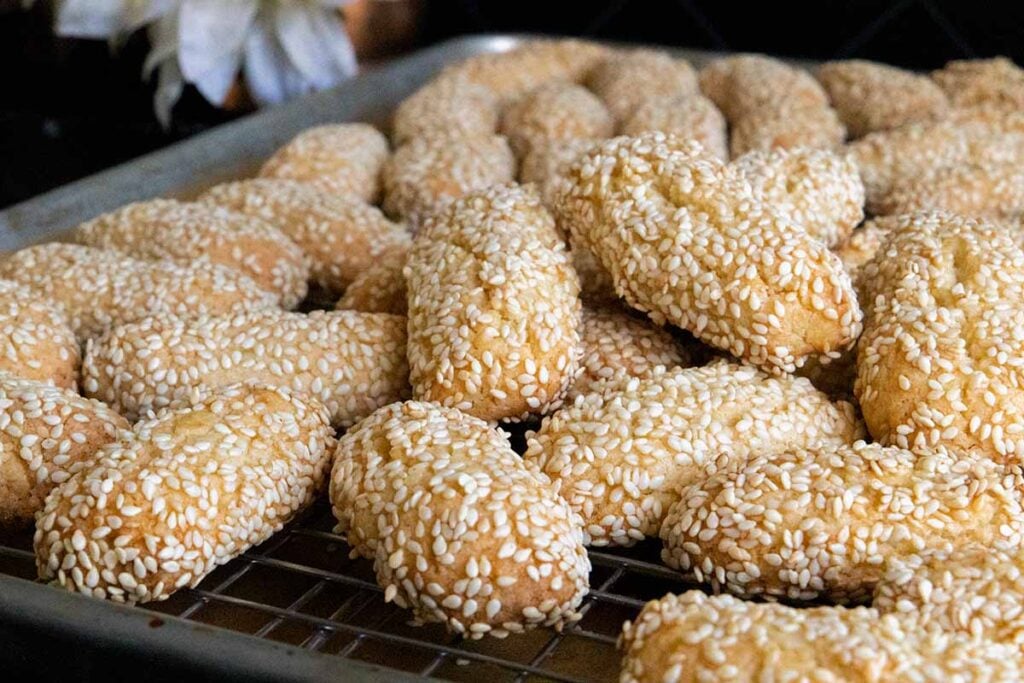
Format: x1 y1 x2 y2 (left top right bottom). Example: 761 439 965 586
662 441 1024 602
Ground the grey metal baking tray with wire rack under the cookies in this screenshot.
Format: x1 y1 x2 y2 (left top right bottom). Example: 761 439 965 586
0 36 737 683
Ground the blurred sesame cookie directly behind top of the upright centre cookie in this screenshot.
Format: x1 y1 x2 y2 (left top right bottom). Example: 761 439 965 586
383 134 516 228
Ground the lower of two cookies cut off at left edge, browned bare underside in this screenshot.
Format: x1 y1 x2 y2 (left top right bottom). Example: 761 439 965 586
0 373 129 528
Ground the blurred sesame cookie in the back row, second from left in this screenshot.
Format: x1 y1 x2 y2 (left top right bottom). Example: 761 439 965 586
587 49 698 122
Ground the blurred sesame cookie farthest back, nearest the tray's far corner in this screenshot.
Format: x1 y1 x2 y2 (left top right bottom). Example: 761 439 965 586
440 39 608 102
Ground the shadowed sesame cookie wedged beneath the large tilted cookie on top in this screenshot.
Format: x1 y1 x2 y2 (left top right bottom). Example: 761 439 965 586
566 308 690 402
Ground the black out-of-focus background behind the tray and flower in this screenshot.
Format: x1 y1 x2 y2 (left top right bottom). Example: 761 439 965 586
0 0 1024 207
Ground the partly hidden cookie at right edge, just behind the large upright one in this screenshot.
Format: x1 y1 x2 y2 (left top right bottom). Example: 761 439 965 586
878 161 1024 219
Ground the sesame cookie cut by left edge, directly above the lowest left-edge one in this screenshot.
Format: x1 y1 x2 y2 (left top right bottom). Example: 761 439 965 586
0 280 81 390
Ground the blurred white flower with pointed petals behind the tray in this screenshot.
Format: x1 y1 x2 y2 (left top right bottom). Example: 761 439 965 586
49 0 356 126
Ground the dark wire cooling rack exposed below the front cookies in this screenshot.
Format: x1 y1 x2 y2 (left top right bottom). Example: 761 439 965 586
0 501 693 683
